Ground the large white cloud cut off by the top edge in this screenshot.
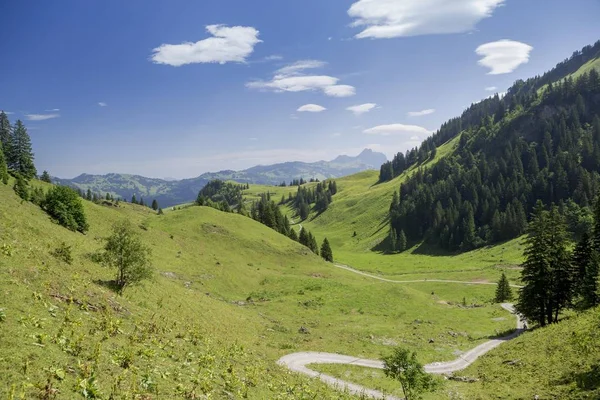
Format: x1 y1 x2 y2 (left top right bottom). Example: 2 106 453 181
348 0 504 39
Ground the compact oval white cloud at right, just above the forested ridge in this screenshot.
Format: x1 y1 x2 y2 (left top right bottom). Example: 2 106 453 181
475 39 533 75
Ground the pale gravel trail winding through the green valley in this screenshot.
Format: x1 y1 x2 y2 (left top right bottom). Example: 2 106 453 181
277 264 527 400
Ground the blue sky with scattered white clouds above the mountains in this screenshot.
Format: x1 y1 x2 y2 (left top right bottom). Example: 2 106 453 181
0 0 600 178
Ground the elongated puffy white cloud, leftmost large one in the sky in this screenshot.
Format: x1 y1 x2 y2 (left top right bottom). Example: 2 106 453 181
150 25 262 67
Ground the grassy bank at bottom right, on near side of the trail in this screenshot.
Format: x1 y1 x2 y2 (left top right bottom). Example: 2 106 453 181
311 308 600 400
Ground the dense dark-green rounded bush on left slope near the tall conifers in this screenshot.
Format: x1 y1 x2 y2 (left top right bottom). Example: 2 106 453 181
43 186 89 233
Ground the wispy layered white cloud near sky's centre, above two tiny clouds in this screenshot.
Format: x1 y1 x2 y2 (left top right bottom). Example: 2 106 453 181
246 60 356 97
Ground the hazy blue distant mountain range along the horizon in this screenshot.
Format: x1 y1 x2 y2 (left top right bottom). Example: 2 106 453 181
53 149 387 207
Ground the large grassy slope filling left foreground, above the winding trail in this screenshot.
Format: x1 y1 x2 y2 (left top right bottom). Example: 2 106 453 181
0 180 512 399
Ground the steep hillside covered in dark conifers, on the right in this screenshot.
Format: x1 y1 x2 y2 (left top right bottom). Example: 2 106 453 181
380 41 600 250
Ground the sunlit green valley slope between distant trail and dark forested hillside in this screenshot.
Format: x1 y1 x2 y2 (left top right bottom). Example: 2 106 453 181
244 134 522 281
